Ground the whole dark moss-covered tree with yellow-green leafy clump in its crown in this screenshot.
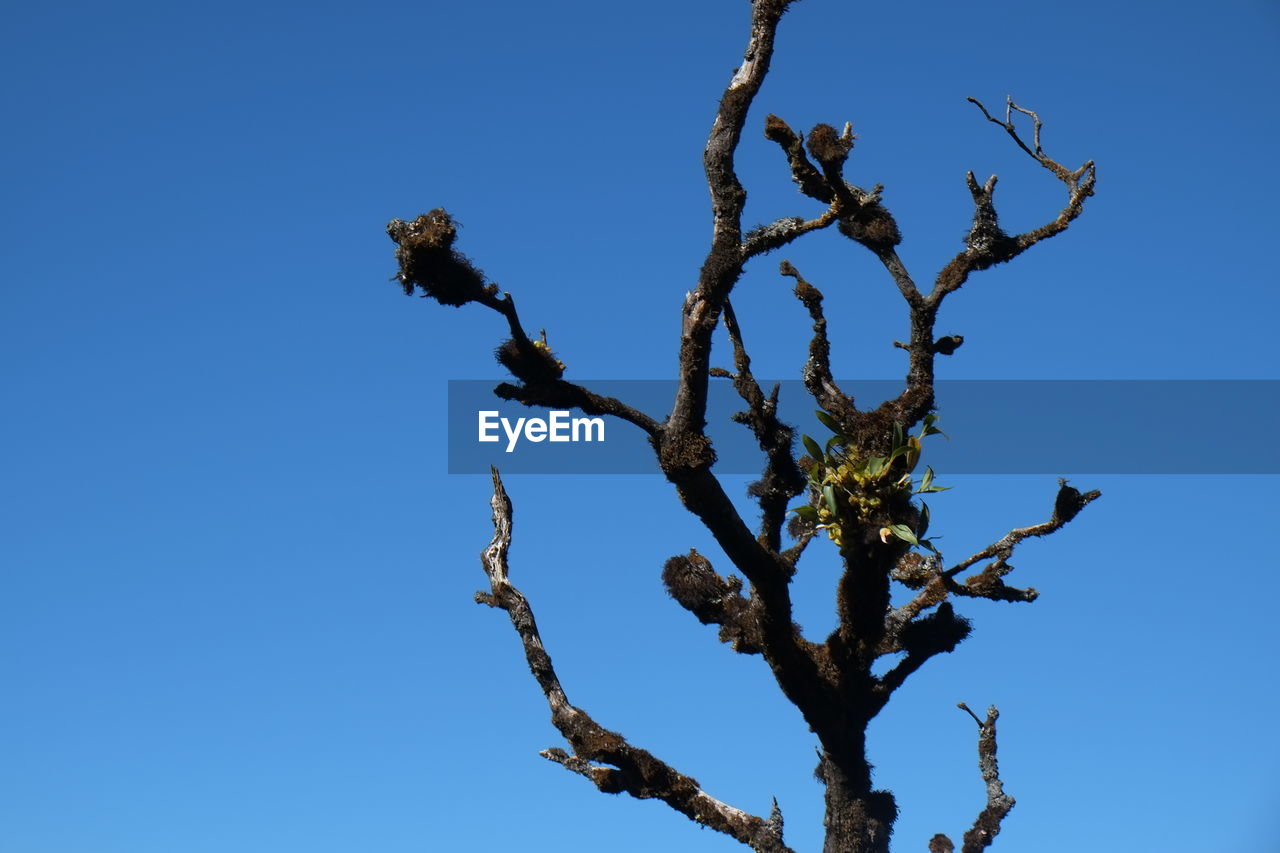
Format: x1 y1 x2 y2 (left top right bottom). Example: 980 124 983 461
387 0 1098 853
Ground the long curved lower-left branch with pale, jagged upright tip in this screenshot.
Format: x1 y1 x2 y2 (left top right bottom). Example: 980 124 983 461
476 469 792 853
